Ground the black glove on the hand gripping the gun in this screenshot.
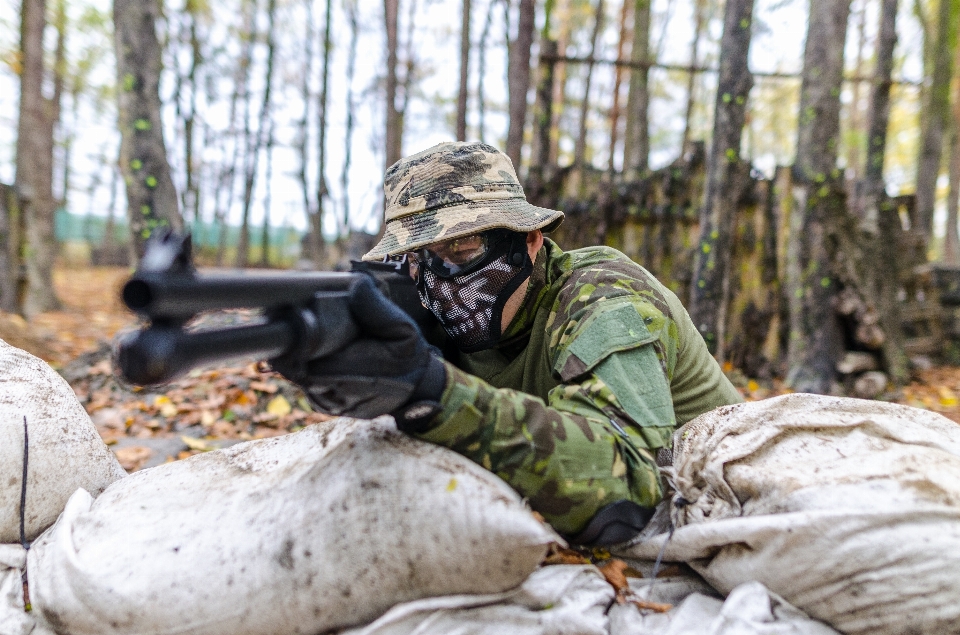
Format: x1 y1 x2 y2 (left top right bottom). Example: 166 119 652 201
270 276 446 431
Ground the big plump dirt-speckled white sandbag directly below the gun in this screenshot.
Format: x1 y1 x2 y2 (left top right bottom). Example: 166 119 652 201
28 417 557 635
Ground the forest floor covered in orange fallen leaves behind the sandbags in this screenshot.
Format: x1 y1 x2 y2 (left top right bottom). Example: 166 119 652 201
7 267 960 471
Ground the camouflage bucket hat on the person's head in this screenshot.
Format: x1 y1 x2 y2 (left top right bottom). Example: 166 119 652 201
363 142 563 260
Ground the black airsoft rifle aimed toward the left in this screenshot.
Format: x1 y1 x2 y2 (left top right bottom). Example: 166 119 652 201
115 231 434 385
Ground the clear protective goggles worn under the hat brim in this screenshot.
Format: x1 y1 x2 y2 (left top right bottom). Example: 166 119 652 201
403 229 523 279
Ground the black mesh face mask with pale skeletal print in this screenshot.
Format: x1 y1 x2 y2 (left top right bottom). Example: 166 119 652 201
417 232 533 353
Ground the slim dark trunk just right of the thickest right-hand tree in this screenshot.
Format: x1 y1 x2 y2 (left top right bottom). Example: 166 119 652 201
858 0 910 384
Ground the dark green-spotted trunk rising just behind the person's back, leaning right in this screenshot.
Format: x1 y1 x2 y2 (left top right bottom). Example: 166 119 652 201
690 0 753 361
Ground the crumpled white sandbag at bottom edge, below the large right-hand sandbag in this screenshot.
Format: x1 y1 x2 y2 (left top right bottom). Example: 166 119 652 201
609 582 839 635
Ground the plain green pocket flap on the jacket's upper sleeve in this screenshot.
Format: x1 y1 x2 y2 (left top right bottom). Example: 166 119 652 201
553 299 657 381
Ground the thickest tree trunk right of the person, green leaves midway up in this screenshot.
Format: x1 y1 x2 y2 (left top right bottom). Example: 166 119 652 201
787 0 850 394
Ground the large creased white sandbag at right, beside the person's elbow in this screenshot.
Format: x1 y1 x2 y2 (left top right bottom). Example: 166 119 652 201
625 395 960 634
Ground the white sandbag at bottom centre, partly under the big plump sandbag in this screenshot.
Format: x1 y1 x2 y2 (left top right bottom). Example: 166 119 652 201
340 565 613 635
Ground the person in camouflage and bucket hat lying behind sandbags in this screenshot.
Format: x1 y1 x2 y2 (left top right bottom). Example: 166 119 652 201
282 142 741 546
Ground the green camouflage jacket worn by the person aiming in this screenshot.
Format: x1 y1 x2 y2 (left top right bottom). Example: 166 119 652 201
408 240 740 535
